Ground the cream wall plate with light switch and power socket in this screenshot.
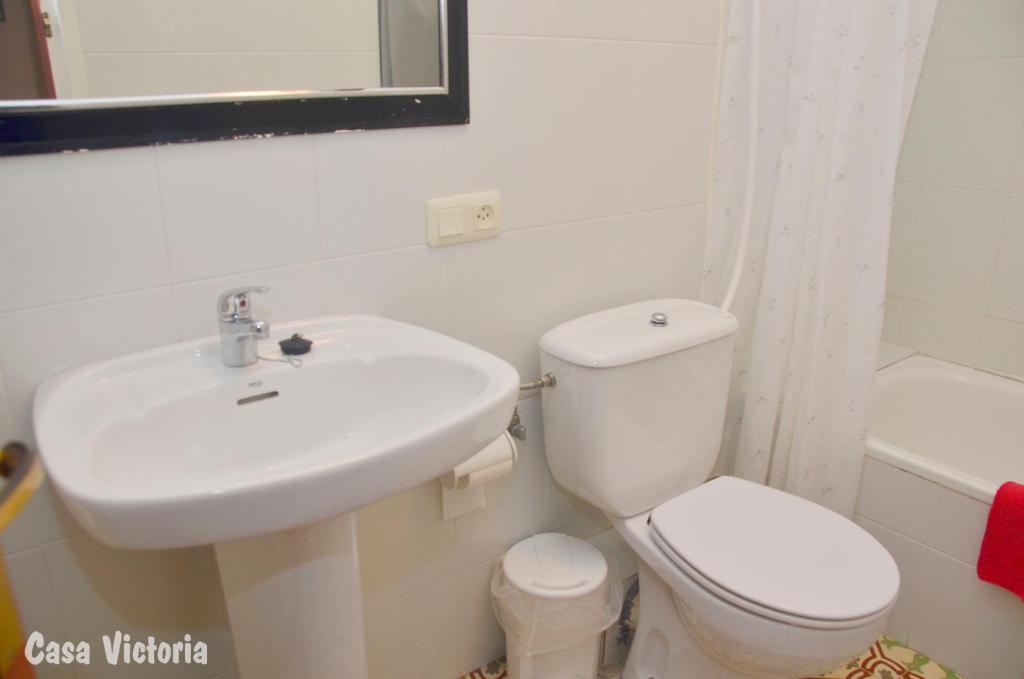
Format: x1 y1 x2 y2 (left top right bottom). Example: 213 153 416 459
427 190 502 247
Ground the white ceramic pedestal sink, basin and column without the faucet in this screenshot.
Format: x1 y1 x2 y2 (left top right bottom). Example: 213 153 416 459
35 315 519 679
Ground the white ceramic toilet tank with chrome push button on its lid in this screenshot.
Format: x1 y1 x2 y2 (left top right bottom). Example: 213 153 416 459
541 299 738 517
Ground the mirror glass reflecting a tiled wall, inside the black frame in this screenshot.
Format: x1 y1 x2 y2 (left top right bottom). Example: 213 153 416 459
0 0 443 100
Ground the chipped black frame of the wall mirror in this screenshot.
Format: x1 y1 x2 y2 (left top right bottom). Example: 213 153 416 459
0 0 469 156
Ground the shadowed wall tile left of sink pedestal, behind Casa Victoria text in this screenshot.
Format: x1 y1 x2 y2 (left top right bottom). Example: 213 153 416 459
44 535 234 679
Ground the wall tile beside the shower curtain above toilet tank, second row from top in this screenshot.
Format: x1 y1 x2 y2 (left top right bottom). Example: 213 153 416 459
552 40 715 220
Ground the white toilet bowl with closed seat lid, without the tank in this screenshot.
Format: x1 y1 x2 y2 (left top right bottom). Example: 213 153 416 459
612 477 899 679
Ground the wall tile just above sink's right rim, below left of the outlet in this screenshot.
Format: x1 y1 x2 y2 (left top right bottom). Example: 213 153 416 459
323 246 449 332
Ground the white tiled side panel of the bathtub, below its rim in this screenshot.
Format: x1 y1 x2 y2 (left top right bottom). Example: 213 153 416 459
855 458 1024 679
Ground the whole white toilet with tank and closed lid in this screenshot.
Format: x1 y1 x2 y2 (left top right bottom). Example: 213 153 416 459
541 299 899 679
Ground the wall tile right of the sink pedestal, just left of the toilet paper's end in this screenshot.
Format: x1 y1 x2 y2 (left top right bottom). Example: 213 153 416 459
357 480 456 609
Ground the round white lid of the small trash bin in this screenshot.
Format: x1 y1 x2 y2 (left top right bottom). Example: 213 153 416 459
502 533 608 598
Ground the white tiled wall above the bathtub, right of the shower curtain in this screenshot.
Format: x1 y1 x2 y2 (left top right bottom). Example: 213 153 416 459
885 0 1024 377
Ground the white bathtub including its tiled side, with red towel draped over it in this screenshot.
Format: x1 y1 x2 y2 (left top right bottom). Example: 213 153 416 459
854 355 1024 679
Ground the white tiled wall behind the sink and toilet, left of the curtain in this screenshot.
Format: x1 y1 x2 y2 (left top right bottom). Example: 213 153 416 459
0 0 718 679
